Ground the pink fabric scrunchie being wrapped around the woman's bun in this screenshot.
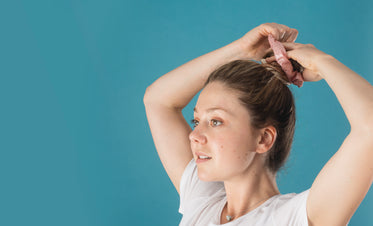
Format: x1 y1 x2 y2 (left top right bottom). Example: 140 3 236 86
268 34 303 88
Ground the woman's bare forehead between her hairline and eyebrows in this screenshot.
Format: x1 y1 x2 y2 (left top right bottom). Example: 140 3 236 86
195 82 246 113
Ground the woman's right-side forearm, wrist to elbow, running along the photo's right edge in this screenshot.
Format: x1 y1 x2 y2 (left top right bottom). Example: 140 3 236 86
318 55 373 131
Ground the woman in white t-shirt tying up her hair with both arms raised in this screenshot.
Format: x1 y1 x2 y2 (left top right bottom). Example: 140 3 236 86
144 23 373 226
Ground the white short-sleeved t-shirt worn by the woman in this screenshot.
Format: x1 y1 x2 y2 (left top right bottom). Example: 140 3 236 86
179 159 309 226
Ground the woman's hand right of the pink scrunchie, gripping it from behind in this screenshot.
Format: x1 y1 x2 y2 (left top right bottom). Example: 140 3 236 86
265 42 330 82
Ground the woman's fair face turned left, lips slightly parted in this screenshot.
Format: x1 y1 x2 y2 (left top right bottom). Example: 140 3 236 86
189 82 258 181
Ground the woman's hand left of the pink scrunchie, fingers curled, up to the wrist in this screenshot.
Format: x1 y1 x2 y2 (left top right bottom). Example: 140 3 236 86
237 23 298 61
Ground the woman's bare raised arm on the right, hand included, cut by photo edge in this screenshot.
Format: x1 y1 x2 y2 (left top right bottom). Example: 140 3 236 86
272 43 373 225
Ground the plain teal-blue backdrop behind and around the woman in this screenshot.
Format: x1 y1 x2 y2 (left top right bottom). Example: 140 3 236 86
0 0 373 226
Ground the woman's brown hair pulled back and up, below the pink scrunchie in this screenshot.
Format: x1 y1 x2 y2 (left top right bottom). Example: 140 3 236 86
204 60 295 174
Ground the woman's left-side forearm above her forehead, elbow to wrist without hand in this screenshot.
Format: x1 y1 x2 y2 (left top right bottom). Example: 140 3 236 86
144 41 250 109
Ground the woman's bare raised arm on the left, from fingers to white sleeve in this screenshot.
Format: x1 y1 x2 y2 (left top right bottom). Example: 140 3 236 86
144 23 298 192
